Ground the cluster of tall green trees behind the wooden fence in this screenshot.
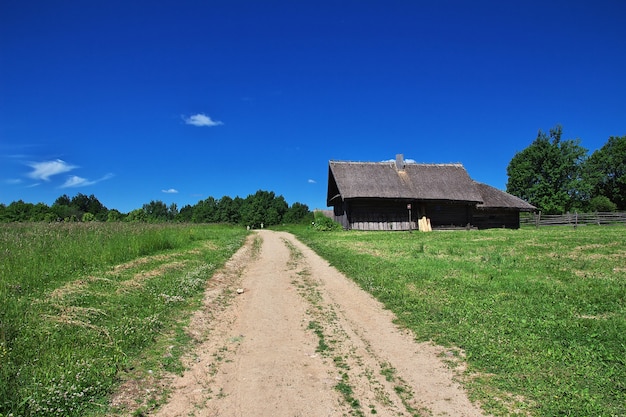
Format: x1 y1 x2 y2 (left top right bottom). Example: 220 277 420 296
506 125 626 214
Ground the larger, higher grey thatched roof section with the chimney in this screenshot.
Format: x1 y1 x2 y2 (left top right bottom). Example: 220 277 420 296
327 161 482 205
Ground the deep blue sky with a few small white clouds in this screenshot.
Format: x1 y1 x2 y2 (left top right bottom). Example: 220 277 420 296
0 0 626 212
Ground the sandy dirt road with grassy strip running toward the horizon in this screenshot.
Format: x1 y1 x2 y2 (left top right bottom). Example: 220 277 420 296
151 230 483 417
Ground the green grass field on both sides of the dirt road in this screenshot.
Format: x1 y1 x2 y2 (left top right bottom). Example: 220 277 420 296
0 223 626 417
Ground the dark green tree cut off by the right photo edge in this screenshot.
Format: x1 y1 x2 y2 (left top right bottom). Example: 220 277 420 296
584 136 626 210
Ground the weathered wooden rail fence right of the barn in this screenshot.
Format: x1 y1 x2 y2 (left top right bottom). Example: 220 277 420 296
520 212 626 227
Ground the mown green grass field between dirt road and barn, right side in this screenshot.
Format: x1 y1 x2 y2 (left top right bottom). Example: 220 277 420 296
292 226 626 416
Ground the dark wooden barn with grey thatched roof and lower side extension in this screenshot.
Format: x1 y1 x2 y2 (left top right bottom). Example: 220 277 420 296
326 155 535 230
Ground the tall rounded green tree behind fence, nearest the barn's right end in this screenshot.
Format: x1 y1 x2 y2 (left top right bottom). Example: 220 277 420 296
507 125 589 214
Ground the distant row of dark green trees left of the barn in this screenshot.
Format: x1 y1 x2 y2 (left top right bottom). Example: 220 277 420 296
0 190 313 228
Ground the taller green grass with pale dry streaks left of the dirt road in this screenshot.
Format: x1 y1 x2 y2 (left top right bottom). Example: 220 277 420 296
0 223 246 417
